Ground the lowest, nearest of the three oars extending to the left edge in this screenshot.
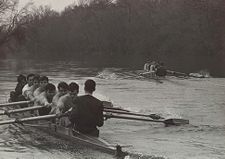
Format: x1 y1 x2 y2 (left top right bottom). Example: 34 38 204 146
0 114 57 125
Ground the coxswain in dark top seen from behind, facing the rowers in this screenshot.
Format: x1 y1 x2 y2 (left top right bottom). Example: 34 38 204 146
69 79 104 137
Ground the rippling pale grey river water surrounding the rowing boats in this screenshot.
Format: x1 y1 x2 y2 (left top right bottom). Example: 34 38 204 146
0 60 225 159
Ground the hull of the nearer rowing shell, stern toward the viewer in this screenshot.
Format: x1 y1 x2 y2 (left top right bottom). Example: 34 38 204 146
4 108 128 158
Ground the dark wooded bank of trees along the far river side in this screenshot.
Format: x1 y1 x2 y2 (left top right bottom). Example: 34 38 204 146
0 0 225 76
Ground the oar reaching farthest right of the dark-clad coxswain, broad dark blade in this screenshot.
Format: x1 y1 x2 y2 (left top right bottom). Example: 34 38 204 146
104 114 189 126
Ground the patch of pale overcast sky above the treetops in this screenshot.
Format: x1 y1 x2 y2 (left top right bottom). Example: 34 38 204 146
19 0 76 11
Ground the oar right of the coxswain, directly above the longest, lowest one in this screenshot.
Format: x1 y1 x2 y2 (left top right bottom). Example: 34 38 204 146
104 109 163 119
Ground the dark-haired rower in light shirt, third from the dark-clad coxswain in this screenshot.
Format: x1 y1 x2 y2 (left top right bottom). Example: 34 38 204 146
35 83 56 115
